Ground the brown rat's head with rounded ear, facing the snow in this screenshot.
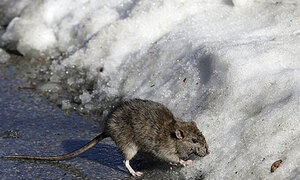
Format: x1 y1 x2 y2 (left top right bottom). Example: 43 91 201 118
174 121 209 157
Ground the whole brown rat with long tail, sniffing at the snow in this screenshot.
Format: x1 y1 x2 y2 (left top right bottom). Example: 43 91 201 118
2 99 209 176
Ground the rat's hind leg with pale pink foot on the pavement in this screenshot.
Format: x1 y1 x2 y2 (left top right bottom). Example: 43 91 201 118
122 143 143 177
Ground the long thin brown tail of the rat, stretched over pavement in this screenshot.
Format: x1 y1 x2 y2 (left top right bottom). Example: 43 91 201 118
2 133 108 161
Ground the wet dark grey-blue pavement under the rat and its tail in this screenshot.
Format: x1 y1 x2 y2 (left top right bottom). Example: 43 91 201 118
0 57 193 180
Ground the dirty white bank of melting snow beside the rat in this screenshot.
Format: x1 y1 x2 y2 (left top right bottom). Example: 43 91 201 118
0 0 300 179
